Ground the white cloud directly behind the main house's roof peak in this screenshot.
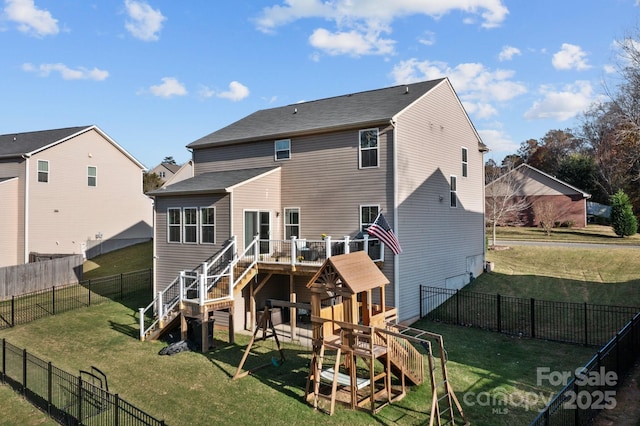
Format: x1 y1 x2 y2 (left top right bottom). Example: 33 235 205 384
392 59 527 119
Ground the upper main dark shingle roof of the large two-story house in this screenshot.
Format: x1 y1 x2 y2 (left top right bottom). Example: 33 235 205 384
187 78 444 149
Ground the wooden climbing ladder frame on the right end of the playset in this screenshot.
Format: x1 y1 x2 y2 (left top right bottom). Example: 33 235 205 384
386 323 469 426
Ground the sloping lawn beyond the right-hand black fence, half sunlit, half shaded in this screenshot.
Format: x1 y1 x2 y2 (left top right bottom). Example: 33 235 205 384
466 246 640 307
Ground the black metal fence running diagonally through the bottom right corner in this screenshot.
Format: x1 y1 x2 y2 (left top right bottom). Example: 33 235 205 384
531 313 640 426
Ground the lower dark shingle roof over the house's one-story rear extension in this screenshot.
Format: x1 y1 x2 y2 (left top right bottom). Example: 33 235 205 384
147 167 278 197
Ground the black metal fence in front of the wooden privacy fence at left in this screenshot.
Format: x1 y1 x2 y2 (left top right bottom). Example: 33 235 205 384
0 269 153 330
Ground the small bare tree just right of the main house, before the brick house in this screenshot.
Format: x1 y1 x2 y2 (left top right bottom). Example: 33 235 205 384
485 164 531 246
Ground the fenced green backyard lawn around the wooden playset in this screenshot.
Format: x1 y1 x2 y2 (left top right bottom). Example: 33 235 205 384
0 302 594 425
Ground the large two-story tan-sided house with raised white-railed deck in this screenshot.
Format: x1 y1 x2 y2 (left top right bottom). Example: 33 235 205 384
149 78 487 329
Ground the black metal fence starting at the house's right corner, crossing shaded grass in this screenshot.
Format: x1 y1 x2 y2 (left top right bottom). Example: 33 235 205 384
420 286 640 346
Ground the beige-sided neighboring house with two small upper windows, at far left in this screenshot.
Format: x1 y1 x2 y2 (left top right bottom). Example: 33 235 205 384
0 126 153 266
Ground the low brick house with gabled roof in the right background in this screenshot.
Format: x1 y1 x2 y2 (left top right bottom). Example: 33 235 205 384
485 164 591 228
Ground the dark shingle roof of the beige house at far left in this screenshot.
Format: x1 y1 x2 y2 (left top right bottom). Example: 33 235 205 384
0 126 93 157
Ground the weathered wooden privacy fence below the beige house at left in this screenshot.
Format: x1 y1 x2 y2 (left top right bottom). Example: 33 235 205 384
0 254 83 300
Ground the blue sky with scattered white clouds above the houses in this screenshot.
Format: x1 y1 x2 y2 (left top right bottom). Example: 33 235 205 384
0 0 640 168
